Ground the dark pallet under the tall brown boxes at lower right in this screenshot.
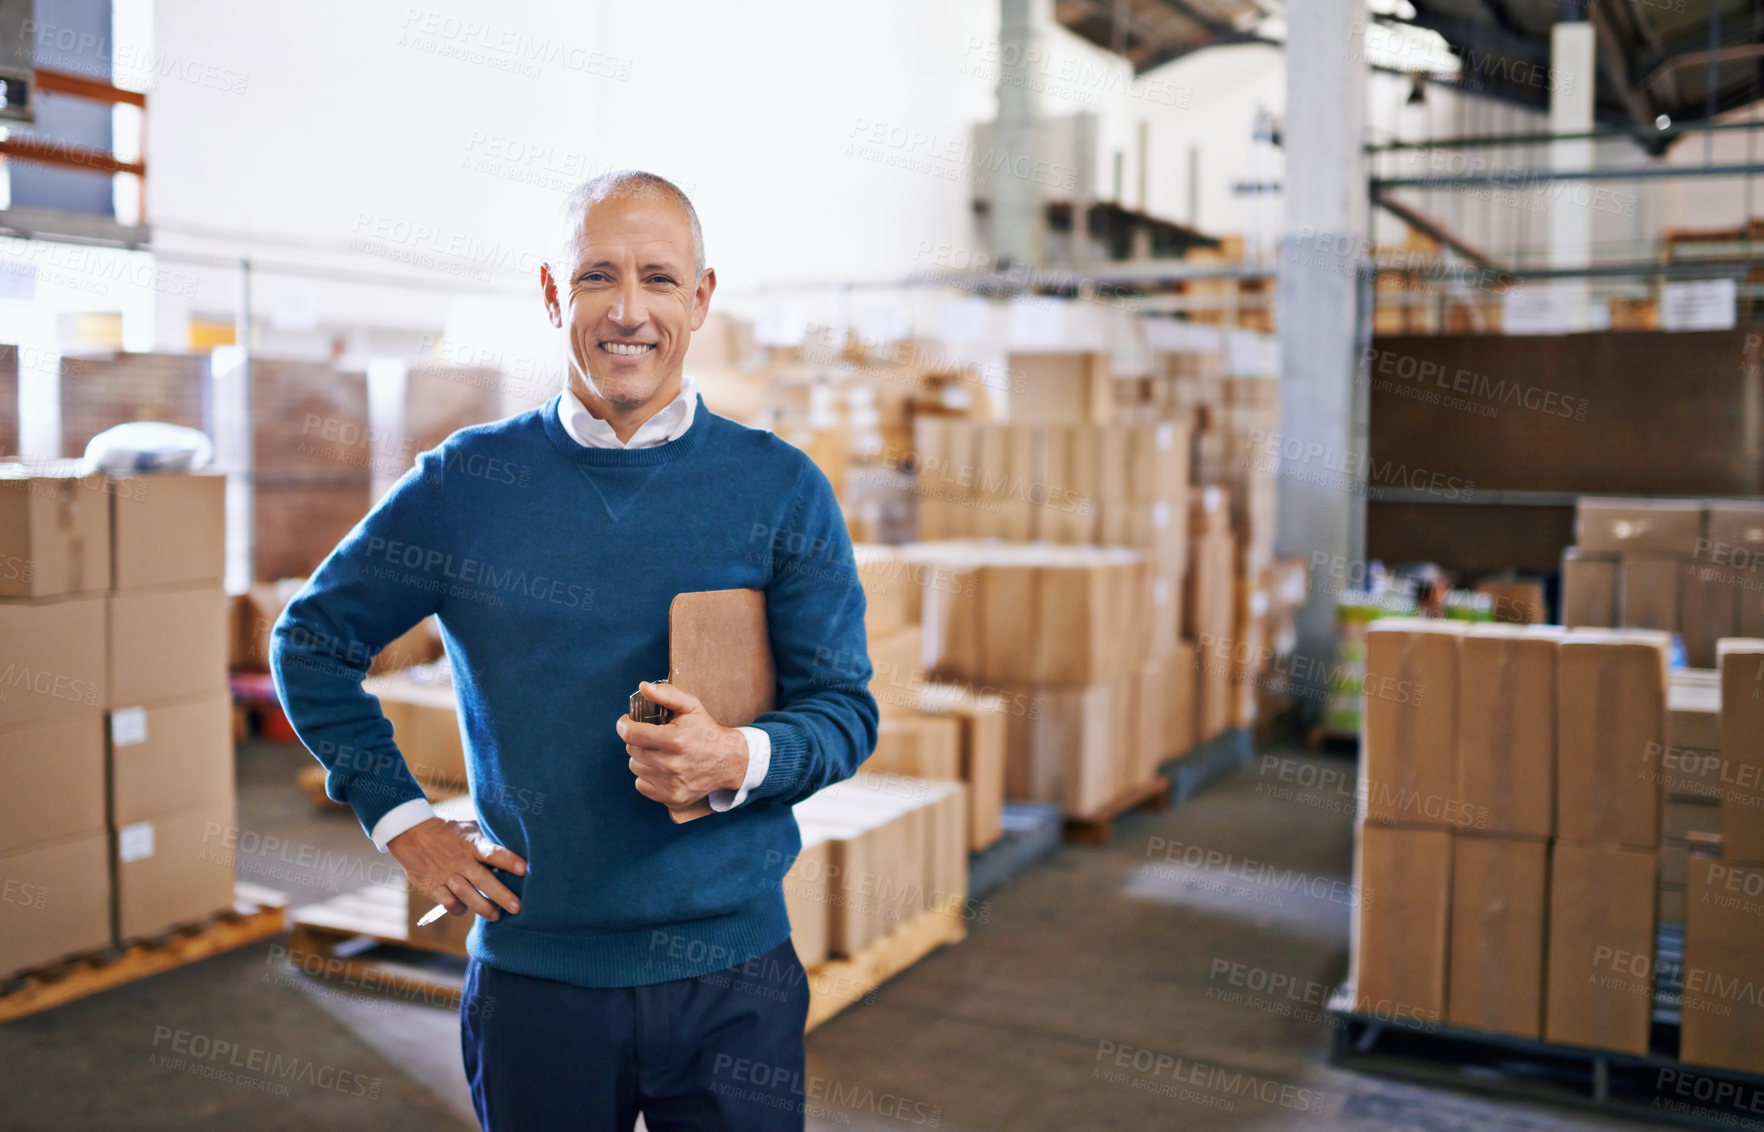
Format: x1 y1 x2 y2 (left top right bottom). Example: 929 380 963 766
1327 991 1764 1128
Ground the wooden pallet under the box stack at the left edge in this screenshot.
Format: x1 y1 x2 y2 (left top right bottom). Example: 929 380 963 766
0 882 288 1023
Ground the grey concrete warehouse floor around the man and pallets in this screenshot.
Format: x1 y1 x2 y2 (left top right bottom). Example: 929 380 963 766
0 742 1633 1132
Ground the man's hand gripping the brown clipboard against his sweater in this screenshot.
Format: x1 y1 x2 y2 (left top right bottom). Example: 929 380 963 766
617 681 748 808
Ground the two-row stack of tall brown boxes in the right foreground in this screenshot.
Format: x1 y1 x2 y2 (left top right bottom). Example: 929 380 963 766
1353 619 1671 1054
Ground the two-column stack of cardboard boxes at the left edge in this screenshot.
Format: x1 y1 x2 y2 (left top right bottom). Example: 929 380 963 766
0 469 233 970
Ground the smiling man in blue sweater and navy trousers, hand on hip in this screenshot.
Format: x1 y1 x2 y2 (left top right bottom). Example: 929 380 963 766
273 171 877 1132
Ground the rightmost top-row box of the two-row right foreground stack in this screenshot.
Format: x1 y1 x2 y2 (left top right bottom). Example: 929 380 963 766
1556 629 1671 850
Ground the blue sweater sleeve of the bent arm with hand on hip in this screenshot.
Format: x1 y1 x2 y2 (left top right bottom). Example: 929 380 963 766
270 448 445 832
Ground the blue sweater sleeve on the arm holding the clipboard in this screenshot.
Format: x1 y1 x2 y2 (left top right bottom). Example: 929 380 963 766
750 458 878 806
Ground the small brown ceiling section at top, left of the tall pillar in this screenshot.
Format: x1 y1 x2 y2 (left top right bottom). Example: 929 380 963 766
1053 0 1270 74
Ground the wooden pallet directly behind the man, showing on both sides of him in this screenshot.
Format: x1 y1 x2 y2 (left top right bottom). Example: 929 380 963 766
288 885 968 1030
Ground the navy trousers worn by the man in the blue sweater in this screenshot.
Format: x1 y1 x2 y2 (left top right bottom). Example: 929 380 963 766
459 940 808 1132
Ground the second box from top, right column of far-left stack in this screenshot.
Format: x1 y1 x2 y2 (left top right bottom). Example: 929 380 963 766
104 585 228 709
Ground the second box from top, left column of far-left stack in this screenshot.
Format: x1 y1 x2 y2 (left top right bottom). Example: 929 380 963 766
0 596 106 728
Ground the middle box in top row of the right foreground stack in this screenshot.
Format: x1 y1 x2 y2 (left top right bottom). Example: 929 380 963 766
1455 624 1561 838
